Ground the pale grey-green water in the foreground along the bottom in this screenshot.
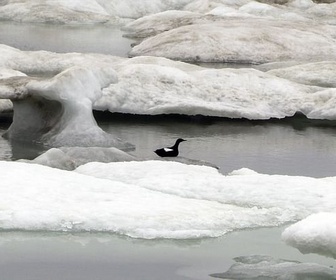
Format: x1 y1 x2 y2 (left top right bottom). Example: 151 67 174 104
0 228 334 280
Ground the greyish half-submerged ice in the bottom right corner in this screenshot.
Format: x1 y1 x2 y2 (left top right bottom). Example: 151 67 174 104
211 255 336 280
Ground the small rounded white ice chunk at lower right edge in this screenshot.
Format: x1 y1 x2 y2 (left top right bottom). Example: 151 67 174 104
282 212 336 259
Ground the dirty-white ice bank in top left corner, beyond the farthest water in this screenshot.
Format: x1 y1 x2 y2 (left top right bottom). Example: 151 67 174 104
0 0 202 24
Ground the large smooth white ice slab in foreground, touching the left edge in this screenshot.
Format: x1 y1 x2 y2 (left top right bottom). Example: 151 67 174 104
0 162 260 239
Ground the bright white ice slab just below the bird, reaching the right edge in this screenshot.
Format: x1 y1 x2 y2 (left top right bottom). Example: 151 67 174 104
76 161 336 223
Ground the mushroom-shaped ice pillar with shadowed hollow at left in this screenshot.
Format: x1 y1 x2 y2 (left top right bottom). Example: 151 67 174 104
0 67 131 149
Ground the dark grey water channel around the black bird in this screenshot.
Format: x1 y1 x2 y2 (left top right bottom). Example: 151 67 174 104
0 115 336 177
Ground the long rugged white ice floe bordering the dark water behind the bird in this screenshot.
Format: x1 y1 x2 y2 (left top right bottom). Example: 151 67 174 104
0 45 336 119
